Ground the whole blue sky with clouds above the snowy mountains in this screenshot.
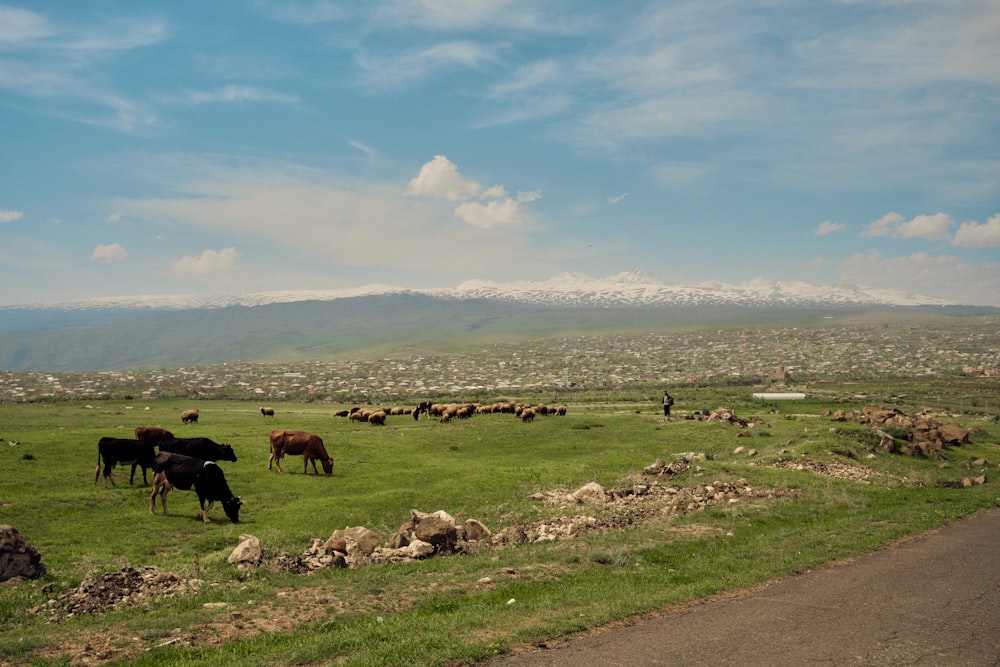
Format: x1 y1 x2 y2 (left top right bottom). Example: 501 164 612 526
0 0 1000 306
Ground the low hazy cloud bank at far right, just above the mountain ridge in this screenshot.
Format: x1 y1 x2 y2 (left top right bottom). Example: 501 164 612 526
839 251 1000 306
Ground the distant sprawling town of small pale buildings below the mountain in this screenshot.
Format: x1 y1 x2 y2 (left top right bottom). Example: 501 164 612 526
0 317 1000 403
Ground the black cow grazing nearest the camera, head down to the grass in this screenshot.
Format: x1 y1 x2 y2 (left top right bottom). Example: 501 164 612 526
149 452 243 523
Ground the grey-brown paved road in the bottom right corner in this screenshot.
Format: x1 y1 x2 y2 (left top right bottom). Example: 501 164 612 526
488 510 1000 667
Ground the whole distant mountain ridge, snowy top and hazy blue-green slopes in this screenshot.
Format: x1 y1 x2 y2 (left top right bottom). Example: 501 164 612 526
0 271 1000 372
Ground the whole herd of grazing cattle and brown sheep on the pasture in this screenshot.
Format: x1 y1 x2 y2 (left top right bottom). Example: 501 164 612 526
94 401 566 523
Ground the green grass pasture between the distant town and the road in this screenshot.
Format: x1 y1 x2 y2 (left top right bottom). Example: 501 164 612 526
0 395 1000 665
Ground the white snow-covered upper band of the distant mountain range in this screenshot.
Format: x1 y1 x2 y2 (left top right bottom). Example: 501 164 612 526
13 270 958 310
